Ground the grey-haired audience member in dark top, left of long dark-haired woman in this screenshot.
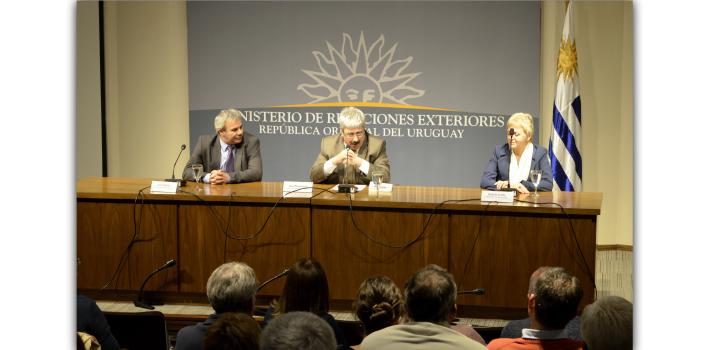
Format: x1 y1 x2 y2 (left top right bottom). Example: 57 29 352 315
175 262 257 350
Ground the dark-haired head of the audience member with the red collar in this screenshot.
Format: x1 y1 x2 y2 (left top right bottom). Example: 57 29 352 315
528 267 583 329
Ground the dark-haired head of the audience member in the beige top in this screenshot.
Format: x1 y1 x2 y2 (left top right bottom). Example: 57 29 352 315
405 265 457 323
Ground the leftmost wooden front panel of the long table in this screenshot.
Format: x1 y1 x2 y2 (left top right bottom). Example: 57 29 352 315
77 201 178 292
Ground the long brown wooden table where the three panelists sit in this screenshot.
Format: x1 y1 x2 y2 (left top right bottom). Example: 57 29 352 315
77 178 602 318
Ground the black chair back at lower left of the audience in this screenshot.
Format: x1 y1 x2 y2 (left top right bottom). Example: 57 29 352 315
104 311 169 350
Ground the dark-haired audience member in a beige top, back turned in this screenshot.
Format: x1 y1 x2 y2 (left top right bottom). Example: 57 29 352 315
360 265 485 350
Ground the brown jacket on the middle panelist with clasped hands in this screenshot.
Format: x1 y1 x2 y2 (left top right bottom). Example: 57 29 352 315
310 134 390 185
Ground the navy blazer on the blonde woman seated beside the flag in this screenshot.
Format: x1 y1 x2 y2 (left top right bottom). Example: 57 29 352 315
480 143 552 192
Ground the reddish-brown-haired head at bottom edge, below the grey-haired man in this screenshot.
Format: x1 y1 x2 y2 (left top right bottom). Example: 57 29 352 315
203 312 260 350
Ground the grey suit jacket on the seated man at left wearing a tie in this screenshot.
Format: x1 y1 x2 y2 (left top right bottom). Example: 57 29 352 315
183 132 262 183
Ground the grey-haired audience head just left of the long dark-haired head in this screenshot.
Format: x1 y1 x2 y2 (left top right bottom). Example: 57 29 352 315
207 261 257 314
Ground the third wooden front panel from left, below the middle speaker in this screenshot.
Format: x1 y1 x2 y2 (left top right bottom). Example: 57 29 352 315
313 207 448 300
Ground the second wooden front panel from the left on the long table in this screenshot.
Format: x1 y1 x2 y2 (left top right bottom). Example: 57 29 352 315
179 204 310 295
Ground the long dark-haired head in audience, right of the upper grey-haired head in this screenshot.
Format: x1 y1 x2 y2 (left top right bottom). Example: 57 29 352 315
278 258 330 315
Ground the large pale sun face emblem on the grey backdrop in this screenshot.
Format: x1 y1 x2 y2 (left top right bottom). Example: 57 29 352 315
298 32 425 104
